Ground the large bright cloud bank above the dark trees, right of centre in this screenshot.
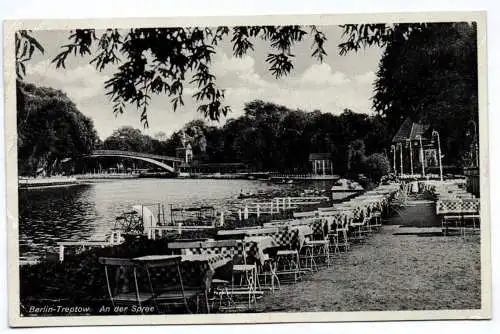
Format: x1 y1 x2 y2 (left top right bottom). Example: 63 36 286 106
209 52 373 118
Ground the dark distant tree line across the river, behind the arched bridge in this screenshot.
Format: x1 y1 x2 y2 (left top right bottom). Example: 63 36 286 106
97 100 391 180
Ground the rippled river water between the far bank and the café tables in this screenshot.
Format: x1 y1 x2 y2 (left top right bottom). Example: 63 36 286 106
19 179 342 260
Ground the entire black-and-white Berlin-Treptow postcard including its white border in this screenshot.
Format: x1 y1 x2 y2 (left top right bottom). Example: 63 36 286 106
4 12 491 327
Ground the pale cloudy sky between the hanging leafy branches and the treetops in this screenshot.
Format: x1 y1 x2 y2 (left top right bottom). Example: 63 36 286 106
25 26 383 139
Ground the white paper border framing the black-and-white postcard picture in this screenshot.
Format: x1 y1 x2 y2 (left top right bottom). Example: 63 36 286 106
4 11 492 327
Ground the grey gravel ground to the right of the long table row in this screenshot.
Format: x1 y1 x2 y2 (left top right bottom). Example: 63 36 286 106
256 225 481 312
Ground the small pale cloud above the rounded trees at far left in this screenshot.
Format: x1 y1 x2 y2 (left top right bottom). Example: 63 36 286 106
26 60 108 103
